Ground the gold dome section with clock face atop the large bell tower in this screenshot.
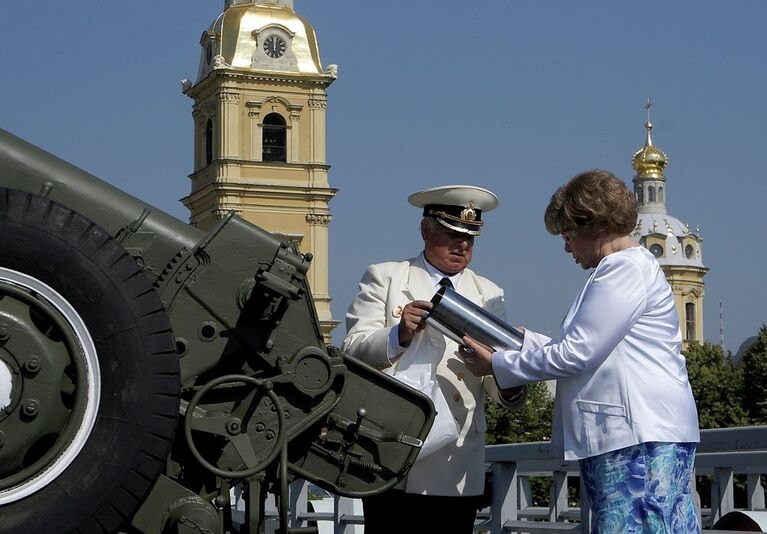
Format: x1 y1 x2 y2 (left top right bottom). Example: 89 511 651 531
200 0 325 79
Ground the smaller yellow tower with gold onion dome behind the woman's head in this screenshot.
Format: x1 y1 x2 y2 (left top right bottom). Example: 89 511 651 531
631 102 708 343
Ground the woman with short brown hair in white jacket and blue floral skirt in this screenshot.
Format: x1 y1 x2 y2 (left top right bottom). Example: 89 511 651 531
460 170 700 534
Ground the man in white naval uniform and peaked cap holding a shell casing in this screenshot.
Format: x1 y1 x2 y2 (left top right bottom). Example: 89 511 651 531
343 185 525 534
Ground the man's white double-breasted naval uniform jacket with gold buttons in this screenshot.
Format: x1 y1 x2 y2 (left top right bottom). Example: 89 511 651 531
343 256 506 498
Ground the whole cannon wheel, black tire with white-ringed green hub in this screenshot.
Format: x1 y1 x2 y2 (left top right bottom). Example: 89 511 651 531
0 188 179 534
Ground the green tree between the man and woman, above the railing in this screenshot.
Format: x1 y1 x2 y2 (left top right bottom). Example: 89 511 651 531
485 382 554 445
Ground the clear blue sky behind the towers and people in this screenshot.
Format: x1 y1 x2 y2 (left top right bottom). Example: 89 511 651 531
0 0 767 351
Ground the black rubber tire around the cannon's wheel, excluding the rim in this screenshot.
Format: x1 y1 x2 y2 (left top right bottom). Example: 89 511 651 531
0 188 180 534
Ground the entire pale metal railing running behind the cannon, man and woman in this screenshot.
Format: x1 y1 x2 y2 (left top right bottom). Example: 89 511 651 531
266 426 767 534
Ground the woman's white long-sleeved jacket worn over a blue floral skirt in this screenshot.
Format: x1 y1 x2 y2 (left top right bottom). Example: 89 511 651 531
493 246 700 460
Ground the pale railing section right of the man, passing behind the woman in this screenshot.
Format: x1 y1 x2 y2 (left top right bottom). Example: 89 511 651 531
477 426 767 533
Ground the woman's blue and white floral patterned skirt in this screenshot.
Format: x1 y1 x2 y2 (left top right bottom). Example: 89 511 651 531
580 442 700 534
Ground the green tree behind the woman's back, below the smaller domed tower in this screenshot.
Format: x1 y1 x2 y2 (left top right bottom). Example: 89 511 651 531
684 341 748 428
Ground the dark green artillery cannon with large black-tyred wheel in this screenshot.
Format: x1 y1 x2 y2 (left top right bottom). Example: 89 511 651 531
0 130 434 534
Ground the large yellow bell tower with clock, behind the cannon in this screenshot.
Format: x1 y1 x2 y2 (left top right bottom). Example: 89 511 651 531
182 0 338 342
